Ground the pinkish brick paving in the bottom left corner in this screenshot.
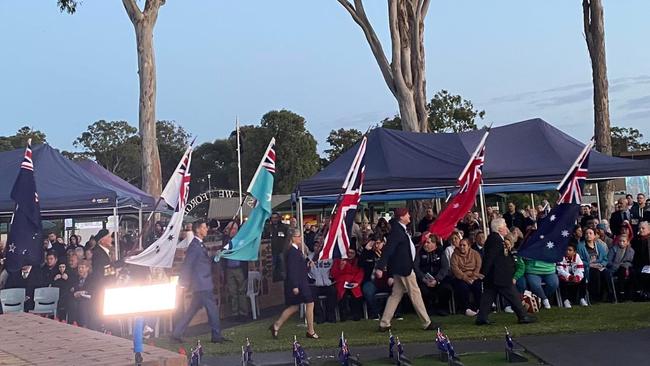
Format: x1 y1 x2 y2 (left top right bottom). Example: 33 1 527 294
0 313 187 366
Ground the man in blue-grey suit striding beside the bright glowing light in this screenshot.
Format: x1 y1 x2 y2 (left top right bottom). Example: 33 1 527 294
171 220 227 343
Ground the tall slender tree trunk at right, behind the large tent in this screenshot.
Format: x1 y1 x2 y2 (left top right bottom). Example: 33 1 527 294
582 0 614 217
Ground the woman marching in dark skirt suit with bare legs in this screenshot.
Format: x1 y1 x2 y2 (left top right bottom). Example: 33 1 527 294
269 229 319 339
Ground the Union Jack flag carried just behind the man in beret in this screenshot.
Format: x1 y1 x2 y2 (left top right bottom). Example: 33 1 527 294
319 136 368 260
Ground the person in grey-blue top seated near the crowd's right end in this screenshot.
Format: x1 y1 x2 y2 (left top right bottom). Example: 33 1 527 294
605 234 634 301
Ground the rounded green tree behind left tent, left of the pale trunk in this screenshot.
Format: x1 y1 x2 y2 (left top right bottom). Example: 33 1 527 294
72 120 142 185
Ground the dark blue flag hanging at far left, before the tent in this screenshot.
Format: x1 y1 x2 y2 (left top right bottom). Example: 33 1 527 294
5 139 43 272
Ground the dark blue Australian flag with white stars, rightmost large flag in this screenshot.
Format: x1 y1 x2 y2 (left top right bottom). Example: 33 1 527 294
518 139 594 263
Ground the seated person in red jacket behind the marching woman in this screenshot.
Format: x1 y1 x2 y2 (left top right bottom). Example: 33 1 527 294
330 248 363 321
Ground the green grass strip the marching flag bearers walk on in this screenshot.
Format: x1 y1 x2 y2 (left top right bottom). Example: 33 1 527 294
155 303 650 355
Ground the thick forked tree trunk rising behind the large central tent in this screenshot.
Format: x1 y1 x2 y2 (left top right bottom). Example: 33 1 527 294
338 0 429 132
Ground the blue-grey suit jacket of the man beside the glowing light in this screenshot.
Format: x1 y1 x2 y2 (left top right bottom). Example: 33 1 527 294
180 238 214 292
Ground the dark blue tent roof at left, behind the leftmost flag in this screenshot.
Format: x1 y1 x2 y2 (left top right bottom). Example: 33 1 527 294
0 144 152 216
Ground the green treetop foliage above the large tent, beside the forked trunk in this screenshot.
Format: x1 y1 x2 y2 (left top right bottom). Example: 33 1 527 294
380 89 485 132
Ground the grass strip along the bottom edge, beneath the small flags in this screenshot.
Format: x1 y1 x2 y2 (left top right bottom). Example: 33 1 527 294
322 352 540 366
